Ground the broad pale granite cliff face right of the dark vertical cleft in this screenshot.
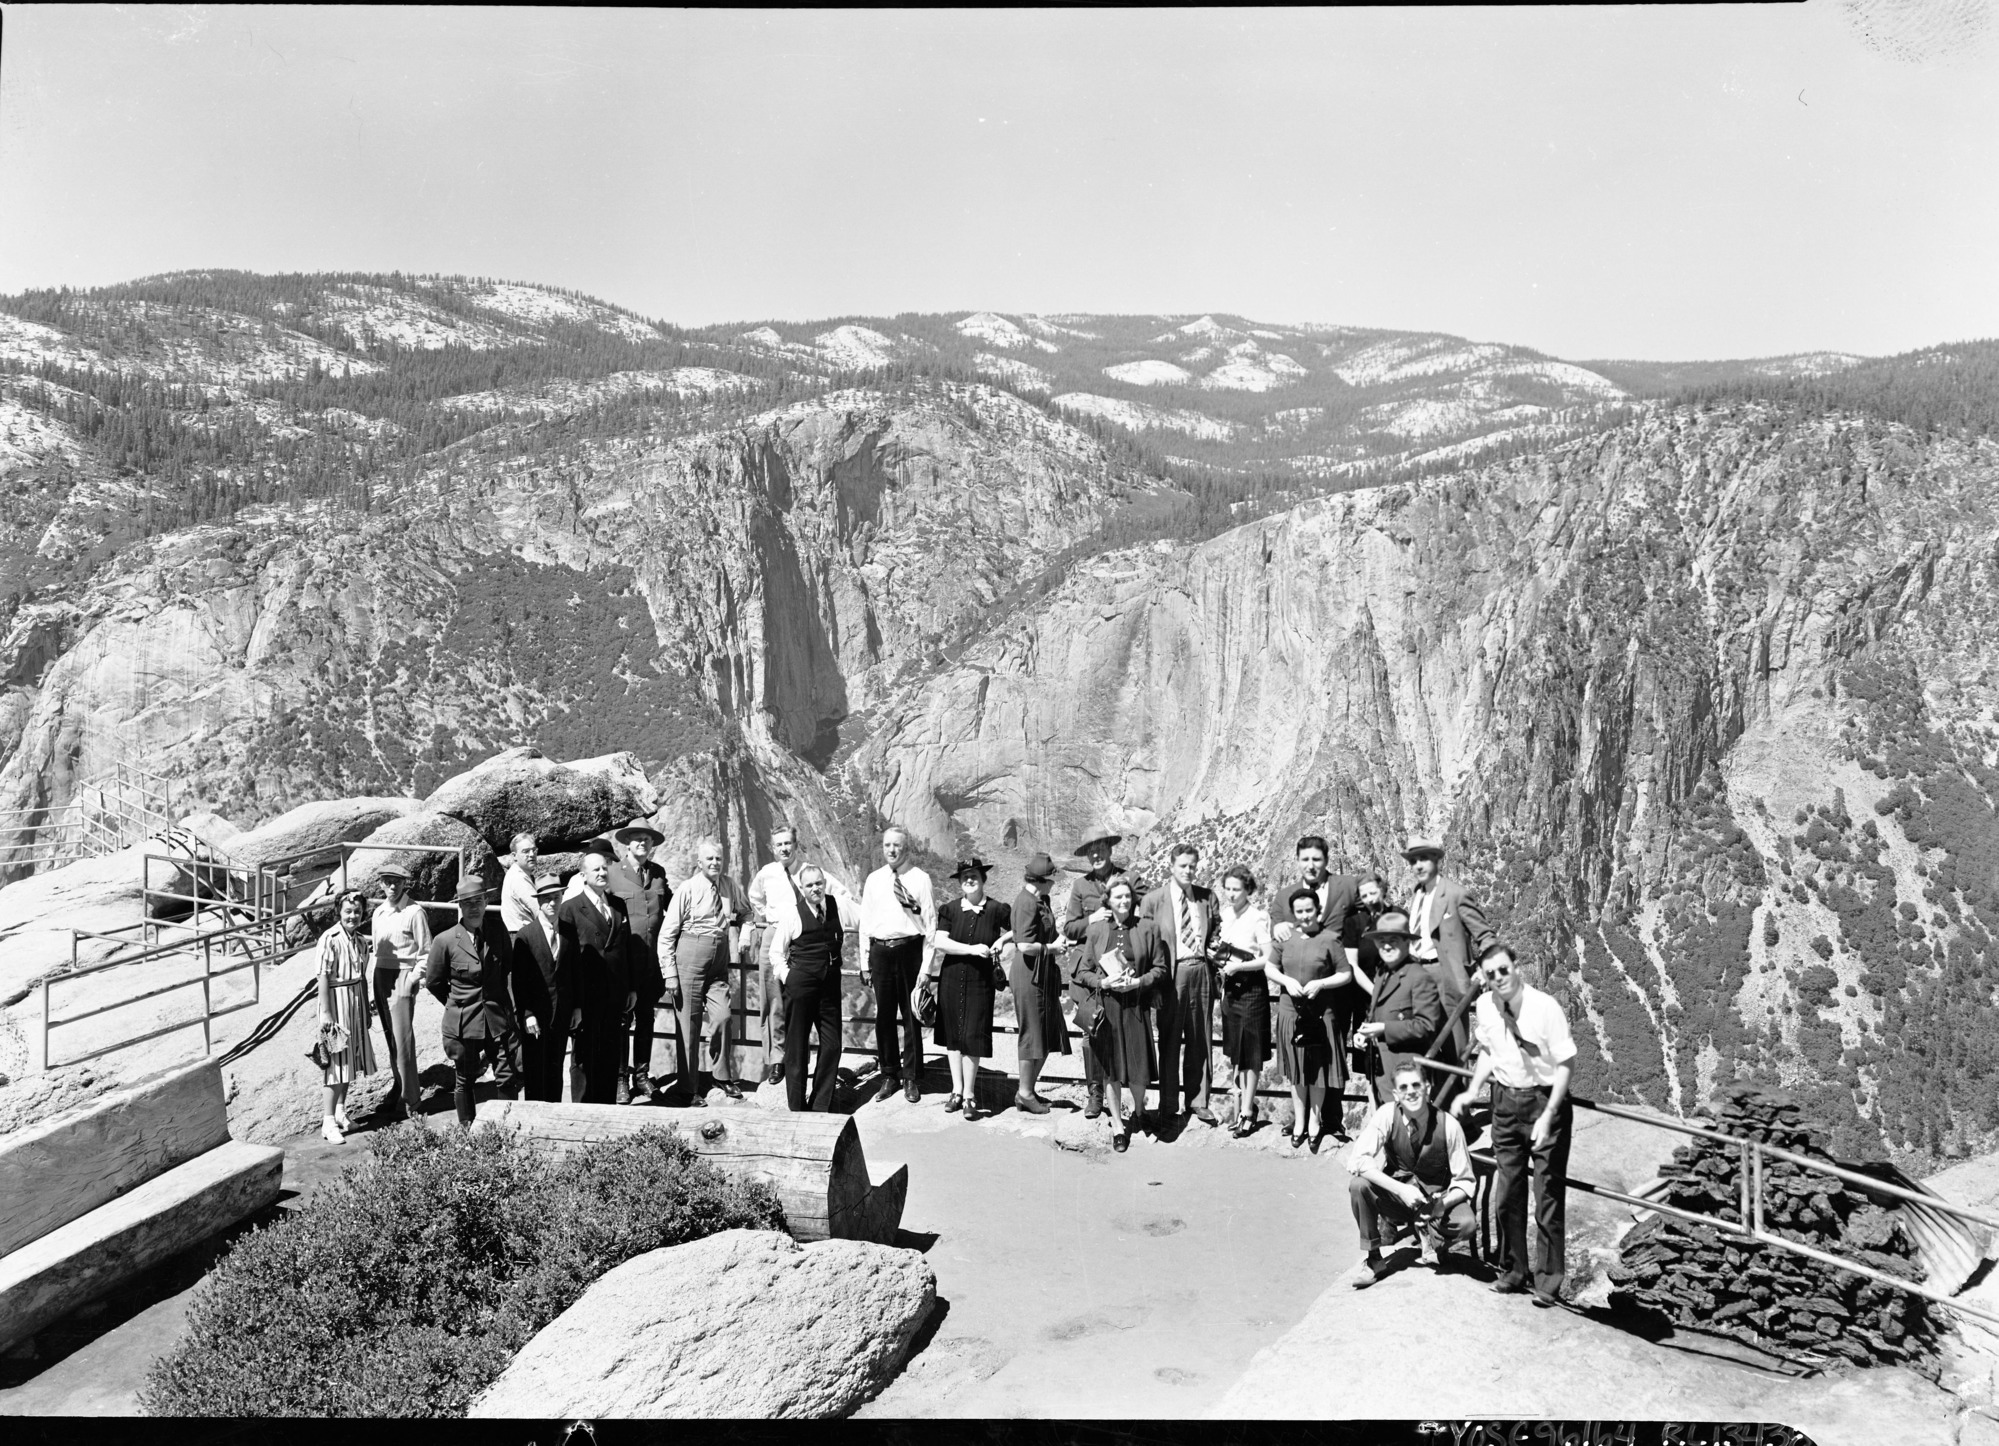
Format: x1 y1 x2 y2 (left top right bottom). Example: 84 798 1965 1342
852 408 1999 1138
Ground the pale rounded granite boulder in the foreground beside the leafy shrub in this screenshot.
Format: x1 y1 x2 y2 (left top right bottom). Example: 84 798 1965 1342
468 1230 938 1420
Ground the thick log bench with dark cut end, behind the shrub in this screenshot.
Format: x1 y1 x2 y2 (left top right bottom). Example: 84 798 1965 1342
480 1100 910 1246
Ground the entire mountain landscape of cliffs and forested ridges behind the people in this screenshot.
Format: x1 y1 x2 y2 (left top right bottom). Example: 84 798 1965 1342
0 272 1999 1158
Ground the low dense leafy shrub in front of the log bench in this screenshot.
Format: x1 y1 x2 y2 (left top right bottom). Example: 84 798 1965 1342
140 1126 784 1416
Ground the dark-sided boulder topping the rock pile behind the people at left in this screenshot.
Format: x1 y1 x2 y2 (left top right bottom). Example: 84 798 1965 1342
424 748 660 854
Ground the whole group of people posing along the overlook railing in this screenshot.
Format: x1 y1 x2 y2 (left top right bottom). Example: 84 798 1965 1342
320 824 1575 1304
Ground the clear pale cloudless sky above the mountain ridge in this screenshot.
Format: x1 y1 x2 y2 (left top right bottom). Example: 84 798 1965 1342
0 0 1999 358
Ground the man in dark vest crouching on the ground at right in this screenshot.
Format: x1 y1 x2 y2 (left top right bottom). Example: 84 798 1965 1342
1347 1062 1479 1290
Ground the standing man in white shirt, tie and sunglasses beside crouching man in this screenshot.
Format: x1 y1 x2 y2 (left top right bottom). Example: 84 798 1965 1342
1451 944 1575 1306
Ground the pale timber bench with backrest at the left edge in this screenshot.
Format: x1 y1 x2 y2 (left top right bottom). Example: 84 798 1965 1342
0 1062 284 1350
